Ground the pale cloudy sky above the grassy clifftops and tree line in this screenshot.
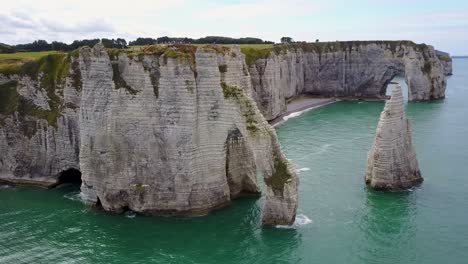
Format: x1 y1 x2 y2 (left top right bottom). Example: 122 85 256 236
0 0 468 55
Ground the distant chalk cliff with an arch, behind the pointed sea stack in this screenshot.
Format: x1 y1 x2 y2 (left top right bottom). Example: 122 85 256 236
246 41 451 120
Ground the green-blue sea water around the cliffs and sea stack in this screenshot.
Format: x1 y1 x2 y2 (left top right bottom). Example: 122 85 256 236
0 59 468 264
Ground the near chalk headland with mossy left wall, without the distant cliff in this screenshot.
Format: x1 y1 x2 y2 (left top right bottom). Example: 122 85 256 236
0 45 298 224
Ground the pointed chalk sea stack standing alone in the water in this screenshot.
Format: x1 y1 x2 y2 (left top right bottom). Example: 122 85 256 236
365 86 423 191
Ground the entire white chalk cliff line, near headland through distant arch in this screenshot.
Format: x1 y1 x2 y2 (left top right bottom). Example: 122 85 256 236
0 42 449 225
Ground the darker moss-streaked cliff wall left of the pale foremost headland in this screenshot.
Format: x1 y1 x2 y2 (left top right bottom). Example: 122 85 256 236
0 56 80 186
